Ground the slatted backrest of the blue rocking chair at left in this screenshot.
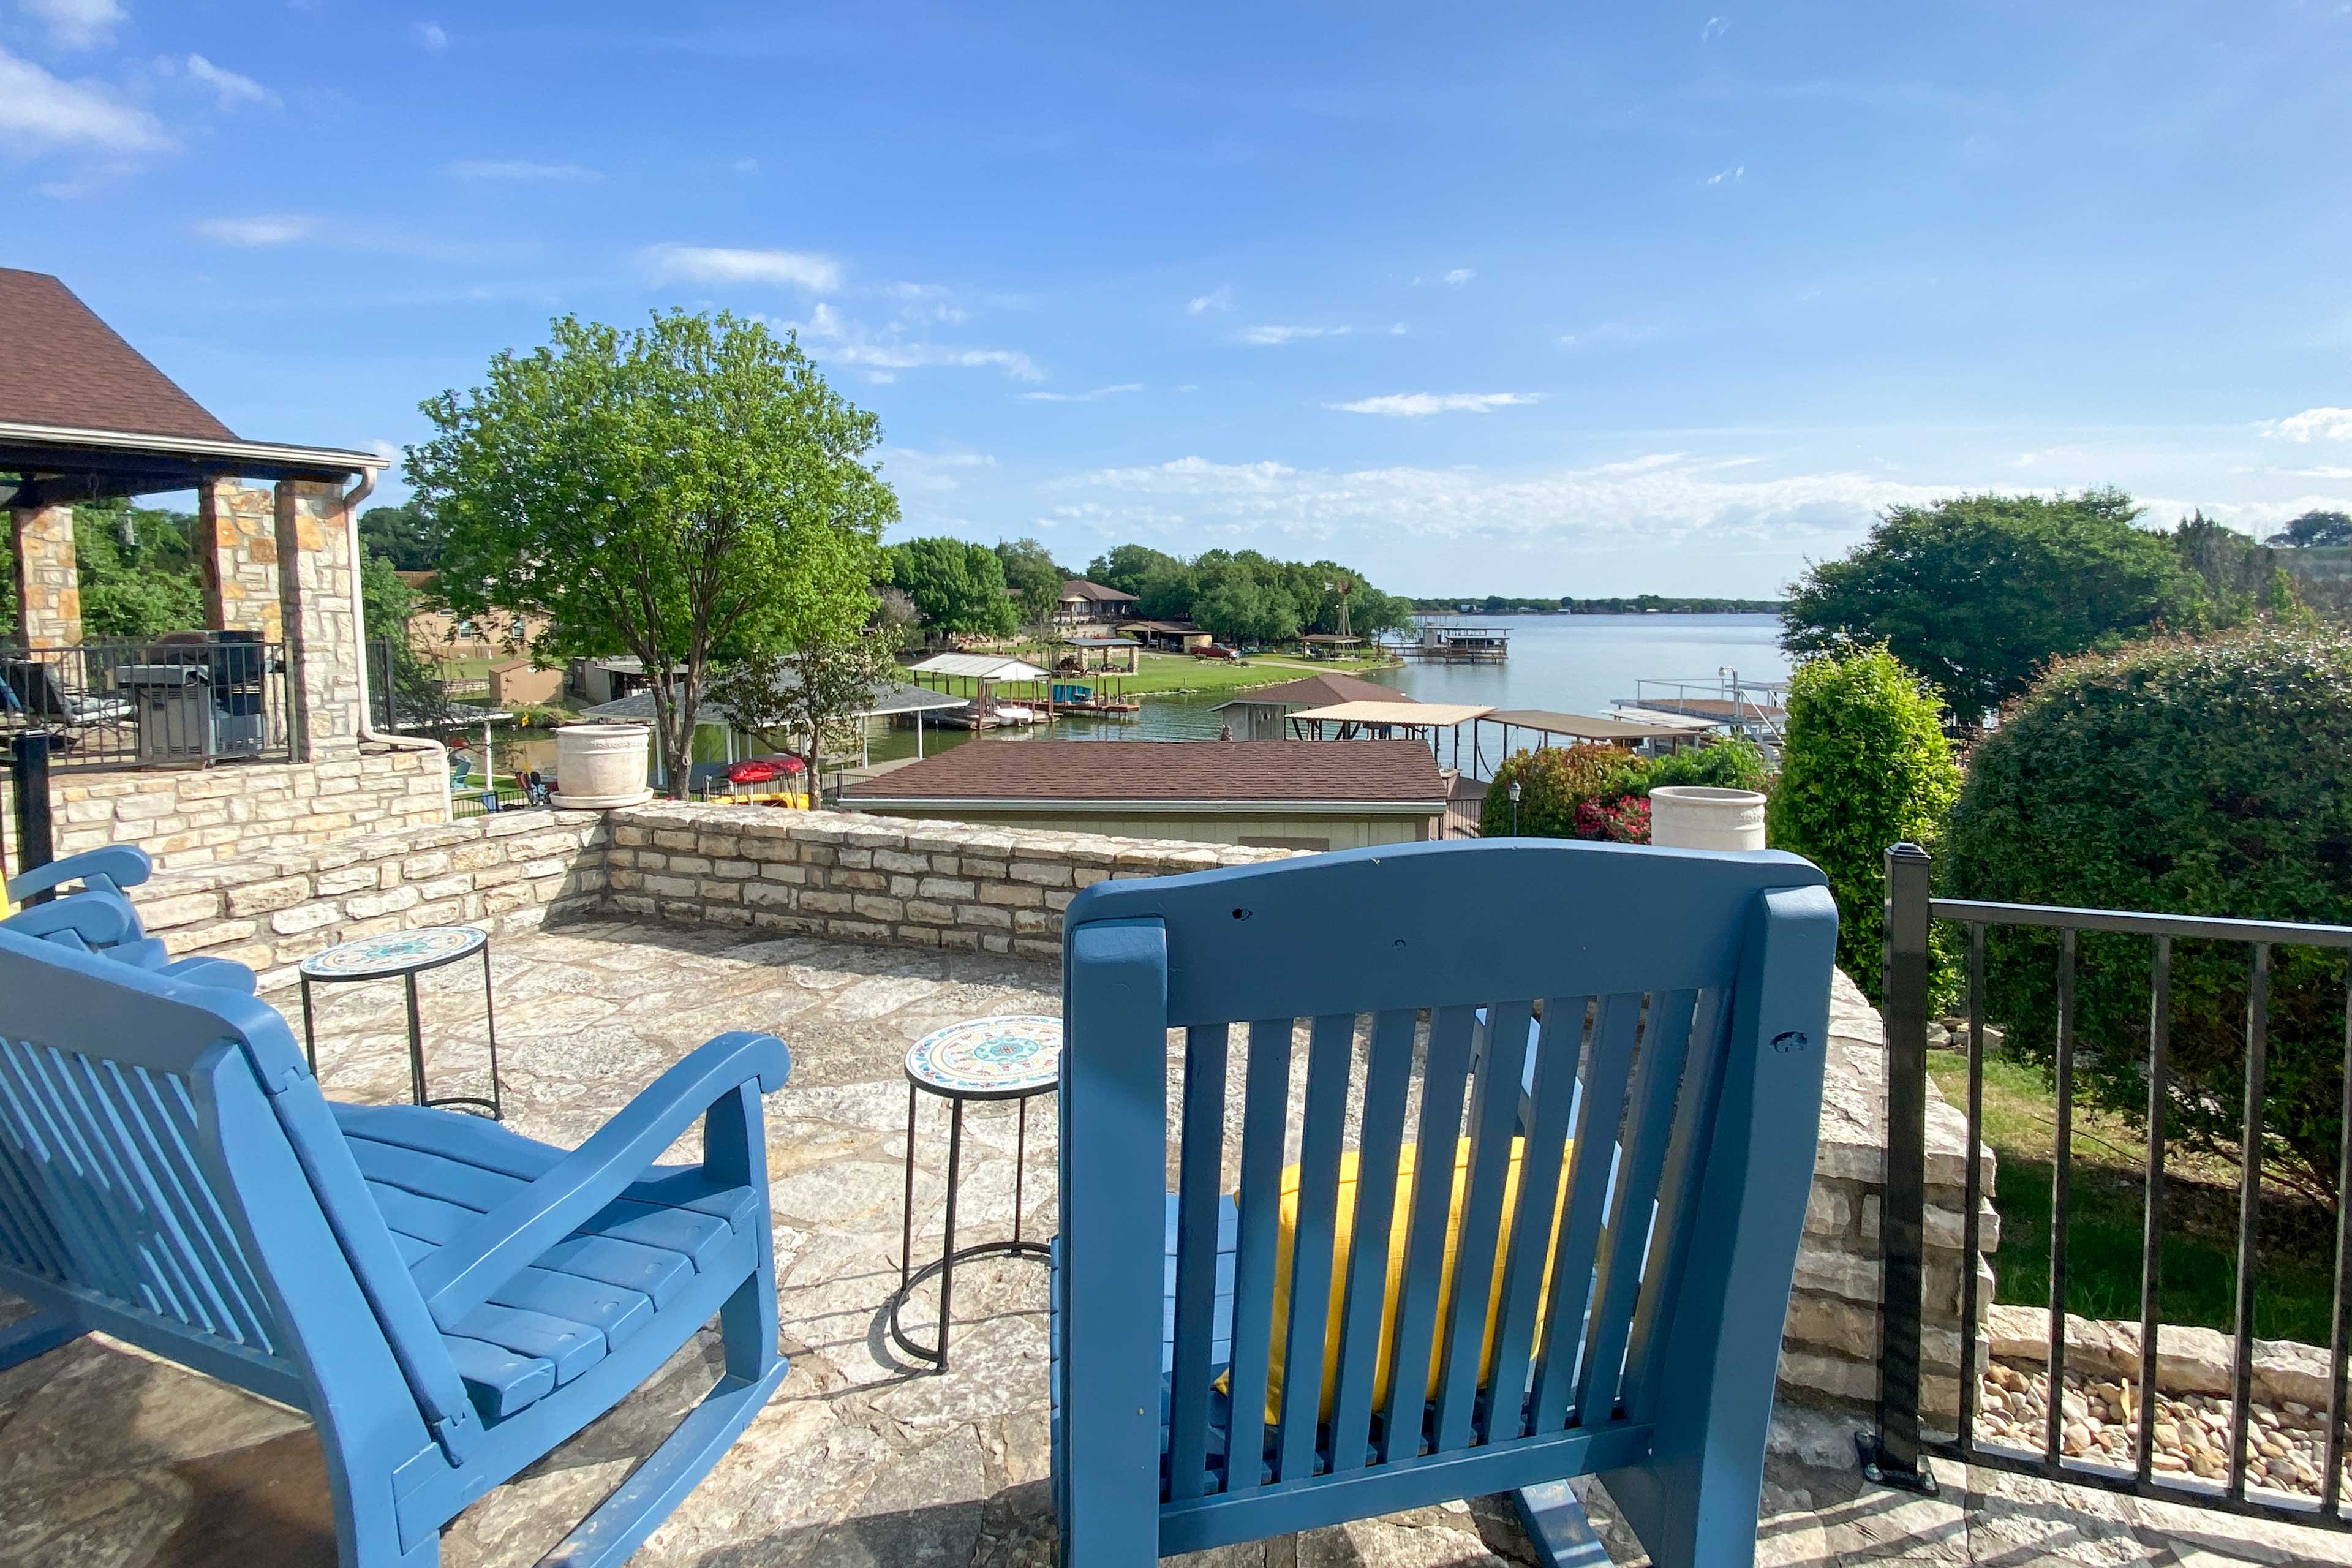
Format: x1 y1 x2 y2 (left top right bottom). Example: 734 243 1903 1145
0 929 473 1444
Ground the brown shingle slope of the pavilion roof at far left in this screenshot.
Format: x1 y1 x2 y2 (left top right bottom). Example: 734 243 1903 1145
0 268 238 442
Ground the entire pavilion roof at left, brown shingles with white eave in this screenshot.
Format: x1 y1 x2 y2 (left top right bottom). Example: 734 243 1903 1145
0 268 386 505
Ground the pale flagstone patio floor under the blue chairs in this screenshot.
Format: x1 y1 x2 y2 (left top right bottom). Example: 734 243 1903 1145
0 924 2352 1568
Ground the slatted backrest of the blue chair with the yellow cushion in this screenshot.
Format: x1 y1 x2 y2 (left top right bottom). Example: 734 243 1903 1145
1061 842 1834 1549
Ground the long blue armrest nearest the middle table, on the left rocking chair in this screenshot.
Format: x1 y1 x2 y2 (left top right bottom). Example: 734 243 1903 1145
414 1032 793 1330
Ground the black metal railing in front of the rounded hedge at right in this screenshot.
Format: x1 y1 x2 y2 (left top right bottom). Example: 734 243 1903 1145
1860 844 2352 1528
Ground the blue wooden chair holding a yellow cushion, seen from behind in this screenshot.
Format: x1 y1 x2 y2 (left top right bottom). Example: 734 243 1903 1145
1049 839 1837 1568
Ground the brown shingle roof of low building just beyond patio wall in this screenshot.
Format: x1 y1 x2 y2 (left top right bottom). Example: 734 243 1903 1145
842 741 1447 809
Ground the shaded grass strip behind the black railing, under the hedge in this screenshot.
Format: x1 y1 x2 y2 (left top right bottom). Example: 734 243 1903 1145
1929 1051 2335 1344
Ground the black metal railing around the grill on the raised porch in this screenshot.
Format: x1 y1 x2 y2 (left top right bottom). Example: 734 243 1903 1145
0 632 292 774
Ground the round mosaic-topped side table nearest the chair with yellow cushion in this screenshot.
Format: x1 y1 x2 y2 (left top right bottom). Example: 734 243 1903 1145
889 1016 1061 1373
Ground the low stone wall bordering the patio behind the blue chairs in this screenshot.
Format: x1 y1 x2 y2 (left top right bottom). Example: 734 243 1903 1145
119 802 1999 1413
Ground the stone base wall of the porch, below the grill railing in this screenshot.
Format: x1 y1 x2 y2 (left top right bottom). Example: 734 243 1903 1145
0 745 449 870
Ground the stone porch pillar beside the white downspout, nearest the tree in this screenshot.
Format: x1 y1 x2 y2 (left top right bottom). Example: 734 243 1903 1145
277 480 360 762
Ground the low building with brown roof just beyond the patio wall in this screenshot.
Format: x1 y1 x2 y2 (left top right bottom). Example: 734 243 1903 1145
840 741 1447 849
